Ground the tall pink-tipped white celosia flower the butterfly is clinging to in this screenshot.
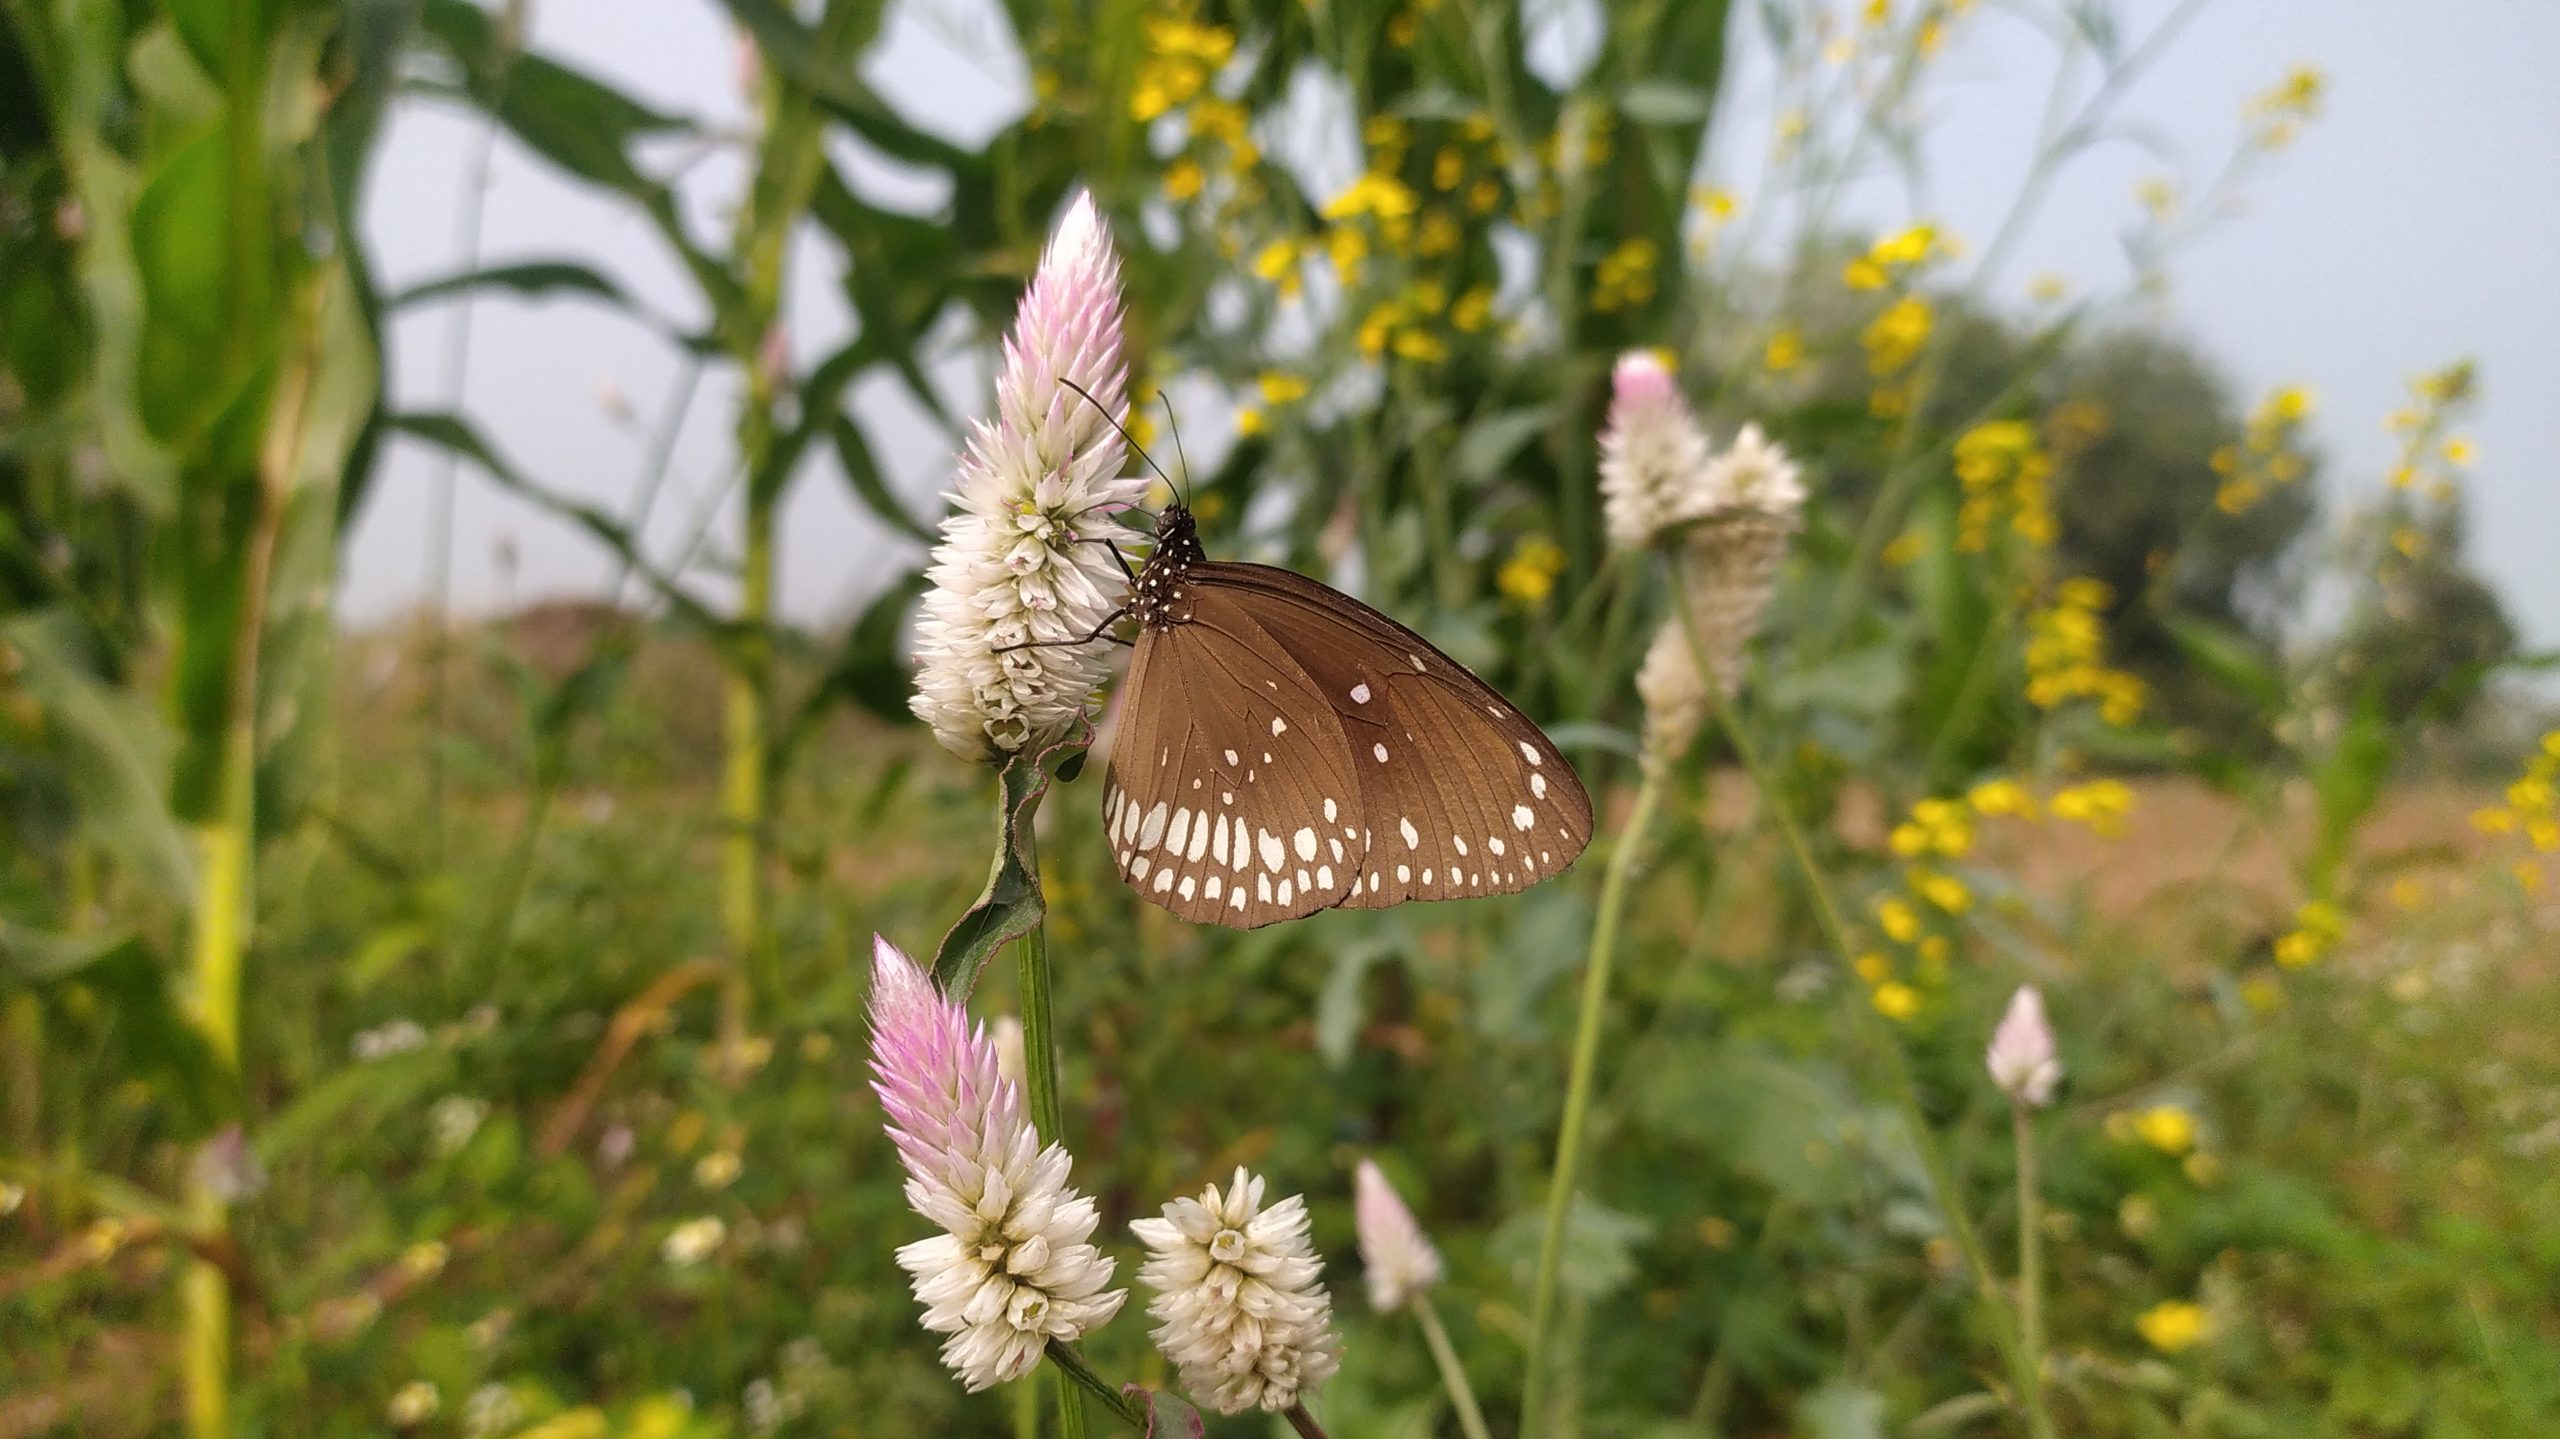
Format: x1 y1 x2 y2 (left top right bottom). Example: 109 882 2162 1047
911 197 1147 760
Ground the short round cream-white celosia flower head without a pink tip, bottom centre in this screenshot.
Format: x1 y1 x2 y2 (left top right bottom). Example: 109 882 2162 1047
1129 1168 1341 1413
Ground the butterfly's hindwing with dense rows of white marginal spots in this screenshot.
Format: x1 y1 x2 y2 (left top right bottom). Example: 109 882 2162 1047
1103 586 1364 929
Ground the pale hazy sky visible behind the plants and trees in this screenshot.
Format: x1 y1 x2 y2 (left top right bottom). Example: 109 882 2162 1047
340 0 2560 648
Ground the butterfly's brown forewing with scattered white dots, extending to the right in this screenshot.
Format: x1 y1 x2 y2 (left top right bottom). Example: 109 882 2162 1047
1185 563 1592 909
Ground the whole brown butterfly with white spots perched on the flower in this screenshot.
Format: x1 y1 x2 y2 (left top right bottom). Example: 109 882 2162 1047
1103 504 1592 929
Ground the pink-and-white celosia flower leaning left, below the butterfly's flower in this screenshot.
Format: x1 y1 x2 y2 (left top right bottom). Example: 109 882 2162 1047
870 940 1126 1390
